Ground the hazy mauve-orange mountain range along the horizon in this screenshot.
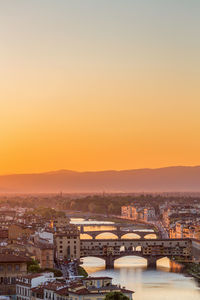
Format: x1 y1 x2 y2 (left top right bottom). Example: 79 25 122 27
0 166 200 193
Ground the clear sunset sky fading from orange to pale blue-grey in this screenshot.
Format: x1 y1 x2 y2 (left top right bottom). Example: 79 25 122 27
0 0 200 174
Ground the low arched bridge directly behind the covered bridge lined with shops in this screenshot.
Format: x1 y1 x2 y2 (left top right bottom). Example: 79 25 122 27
80 225 159 239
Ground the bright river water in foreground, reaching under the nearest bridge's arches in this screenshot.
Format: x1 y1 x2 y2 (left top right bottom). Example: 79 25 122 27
83 256 200 300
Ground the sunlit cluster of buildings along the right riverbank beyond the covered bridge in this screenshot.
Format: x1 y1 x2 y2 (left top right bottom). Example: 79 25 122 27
121 201 200 240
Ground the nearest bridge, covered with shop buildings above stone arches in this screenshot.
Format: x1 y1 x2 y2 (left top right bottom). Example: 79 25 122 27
81 239 192 268
